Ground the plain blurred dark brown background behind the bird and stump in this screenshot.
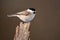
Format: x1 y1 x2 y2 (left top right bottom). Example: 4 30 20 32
0 0 60 40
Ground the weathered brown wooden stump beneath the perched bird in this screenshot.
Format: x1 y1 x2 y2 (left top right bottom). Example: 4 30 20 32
14 22 30 40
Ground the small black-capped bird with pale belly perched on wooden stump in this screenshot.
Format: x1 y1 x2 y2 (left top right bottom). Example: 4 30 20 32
7 8 36 22
